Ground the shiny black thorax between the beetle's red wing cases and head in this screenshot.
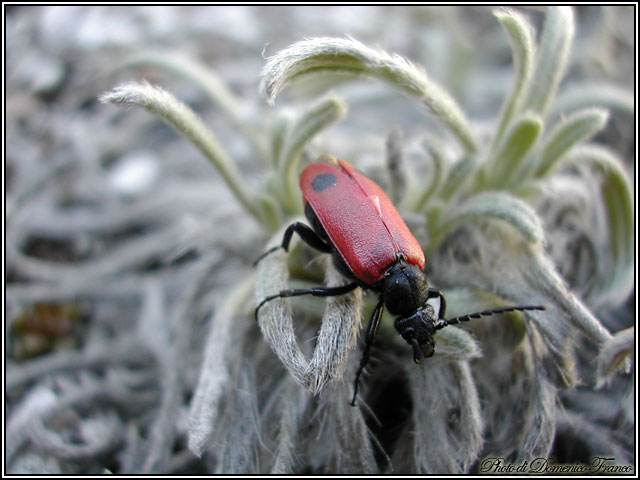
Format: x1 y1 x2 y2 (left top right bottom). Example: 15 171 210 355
381 260 429 317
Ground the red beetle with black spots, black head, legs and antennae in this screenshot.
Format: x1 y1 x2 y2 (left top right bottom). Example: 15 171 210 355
254 155 545 406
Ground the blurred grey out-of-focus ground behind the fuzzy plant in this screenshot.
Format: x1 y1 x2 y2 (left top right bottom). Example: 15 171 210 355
3 5 636 473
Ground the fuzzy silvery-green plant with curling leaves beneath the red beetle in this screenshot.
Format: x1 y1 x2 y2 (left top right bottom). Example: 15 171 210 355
79 6 635 474
